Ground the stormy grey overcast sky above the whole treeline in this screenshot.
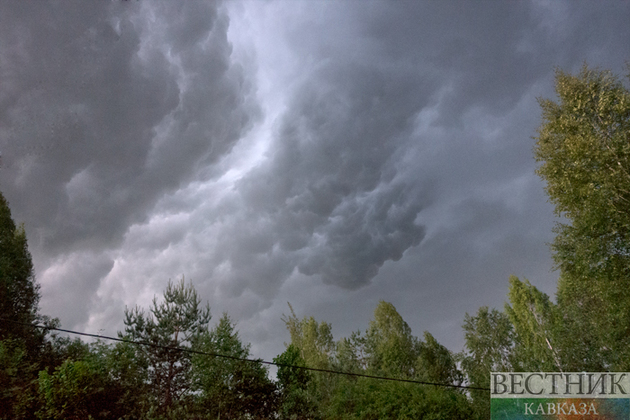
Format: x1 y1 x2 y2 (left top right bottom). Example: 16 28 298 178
0 0 630 360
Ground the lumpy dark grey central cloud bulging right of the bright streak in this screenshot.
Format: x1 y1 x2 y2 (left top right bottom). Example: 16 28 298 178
232 62 428 289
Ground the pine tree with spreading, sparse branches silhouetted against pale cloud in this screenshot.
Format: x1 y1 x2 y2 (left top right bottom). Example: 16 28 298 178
119 278 210 415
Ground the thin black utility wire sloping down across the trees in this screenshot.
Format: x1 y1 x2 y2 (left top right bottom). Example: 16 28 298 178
0 318 490 391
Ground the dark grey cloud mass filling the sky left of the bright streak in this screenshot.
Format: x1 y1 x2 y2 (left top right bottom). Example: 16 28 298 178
0 2 257 252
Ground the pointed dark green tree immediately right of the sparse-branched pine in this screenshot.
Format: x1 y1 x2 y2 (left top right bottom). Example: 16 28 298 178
193 313 277 419
